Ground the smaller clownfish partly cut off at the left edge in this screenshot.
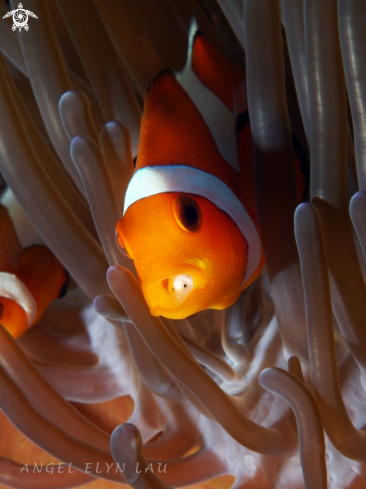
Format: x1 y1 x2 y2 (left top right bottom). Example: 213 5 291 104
0 189 68 338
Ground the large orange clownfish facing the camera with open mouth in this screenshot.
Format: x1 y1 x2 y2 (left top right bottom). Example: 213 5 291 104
116 27 308 319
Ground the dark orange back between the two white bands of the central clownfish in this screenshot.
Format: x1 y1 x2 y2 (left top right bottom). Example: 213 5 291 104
136 70 241 196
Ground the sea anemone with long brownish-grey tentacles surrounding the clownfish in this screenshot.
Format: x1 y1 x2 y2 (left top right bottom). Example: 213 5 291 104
0 0 366 489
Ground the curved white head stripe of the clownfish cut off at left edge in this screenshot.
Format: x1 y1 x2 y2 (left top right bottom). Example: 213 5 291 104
0 272 37 328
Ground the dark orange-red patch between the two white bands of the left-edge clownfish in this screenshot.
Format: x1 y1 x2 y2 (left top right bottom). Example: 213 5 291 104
0 204 23 271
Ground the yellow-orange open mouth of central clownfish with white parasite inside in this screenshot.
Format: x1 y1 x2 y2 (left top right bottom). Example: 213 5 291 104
141 263 211 319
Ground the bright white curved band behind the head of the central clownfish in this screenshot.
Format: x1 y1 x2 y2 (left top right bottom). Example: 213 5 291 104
123 165 261 288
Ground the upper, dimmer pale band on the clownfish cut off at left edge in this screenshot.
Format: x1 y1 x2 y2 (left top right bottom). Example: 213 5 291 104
0 188 44 248
